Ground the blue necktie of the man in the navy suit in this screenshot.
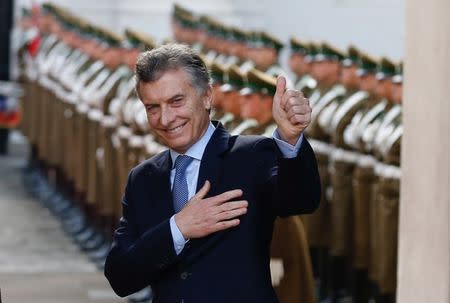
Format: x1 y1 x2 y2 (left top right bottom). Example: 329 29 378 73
172 155 193 213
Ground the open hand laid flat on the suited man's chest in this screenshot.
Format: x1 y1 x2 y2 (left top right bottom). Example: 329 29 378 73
175 181 248 240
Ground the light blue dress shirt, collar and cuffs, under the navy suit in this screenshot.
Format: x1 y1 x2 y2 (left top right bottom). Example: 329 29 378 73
170 122 303 255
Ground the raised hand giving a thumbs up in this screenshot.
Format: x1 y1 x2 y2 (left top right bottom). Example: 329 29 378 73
272 76 311 145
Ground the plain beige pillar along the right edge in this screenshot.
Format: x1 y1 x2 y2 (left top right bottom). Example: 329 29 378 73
397 0 450 303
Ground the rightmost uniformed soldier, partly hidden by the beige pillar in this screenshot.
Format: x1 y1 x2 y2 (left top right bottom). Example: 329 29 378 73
373 64 403 303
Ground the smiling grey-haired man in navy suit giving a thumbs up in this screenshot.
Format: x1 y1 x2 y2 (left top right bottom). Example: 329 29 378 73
105 44 320 303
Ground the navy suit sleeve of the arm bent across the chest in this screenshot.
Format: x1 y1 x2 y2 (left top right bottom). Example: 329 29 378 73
104 171 178 297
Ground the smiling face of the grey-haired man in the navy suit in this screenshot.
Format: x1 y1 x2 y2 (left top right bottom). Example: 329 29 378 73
138 69 212 154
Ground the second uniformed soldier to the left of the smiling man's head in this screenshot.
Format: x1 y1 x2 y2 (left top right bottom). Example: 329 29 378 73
73 29 127 250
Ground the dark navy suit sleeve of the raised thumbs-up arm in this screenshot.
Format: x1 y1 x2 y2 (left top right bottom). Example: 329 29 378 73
260 138 321 217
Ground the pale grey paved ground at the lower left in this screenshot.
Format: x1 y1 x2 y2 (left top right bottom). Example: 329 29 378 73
0 133 125 303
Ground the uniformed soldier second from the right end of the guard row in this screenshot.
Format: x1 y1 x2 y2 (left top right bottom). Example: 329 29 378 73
344 56 394 302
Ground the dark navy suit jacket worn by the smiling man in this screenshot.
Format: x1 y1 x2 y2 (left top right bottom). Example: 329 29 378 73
105 124 320 303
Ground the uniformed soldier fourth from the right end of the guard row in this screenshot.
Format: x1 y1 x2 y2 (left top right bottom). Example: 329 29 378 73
319 46 376 300
